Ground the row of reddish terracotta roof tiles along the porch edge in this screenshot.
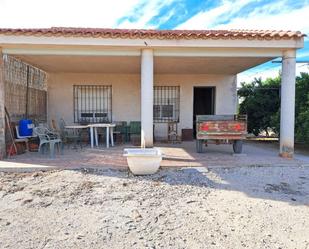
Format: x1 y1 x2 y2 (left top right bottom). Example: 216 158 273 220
0 27 306 40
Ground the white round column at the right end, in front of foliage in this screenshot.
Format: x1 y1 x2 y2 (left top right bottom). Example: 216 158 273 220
280 50 296 158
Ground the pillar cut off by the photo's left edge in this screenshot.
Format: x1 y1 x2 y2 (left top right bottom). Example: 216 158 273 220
0 48 6 160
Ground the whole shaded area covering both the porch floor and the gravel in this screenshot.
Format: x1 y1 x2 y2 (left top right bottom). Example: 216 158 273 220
4 143 309 205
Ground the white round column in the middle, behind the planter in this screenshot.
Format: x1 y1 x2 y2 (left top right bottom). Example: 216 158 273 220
141 49 153 147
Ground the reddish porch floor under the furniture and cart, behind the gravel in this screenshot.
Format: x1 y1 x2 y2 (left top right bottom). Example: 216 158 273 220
0 142 309 171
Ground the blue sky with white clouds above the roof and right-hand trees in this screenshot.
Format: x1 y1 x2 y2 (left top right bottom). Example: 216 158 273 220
0 0 309 81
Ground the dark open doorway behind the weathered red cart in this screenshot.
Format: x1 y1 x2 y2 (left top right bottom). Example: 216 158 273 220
193 87 216 138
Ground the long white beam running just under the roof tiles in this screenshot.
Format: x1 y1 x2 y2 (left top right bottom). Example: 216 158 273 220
0 35 304 48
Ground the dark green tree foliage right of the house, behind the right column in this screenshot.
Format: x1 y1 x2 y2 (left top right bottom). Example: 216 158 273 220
238 73 309 144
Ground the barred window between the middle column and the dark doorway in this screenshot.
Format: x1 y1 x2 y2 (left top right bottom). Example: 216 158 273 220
153 86 180 123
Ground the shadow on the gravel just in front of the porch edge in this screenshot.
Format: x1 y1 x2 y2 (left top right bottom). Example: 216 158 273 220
72 166 309 207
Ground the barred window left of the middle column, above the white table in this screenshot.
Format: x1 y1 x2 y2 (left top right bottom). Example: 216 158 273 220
73 85 112 123
